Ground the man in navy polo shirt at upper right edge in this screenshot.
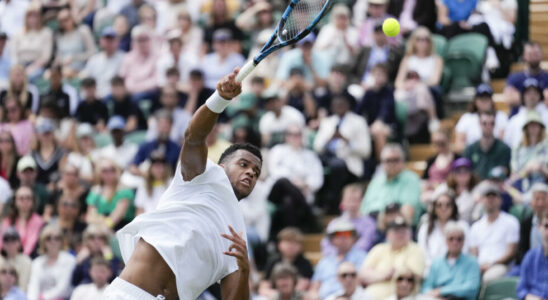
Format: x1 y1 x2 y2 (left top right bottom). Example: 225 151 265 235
504 41 548 115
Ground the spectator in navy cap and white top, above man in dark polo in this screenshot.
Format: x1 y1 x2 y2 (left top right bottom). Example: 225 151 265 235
454 84 508 153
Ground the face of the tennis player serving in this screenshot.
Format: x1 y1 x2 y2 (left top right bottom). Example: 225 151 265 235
224 149 262 200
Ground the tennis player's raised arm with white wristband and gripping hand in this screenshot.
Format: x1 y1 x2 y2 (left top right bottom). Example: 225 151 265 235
181 68 242 181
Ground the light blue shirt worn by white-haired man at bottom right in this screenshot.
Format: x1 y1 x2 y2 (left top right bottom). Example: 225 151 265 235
422 254 481 300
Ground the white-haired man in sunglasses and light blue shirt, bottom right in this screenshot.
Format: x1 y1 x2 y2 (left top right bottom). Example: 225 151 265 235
422 221 481 300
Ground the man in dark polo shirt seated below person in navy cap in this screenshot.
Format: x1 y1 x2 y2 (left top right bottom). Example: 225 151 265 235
462 112 511 178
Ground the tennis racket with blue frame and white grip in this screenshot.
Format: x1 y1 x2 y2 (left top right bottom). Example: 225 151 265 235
236 0 331 82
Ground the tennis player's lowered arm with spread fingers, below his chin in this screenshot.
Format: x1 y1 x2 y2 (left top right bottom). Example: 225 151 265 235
221 226 249 300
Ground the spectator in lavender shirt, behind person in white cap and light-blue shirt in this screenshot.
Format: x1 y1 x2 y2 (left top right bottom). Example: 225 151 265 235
322 183 377 255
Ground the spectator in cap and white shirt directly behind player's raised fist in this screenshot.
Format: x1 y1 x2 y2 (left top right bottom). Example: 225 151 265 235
200 29 245 89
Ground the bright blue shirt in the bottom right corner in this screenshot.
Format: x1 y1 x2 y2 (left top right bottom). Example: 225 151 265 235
516 247 548 299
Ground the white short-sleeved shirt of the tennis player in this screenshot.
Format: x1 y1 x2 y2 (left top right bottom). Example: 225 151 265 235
117 160 247 300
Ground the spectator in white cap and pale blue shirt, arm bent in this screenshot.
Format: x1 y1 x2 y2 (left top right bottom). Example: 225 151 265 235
310 219 366 299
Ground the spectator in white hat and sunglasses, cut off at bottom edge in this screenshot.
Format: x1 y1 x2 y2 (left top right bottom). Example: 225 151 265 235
326 262 373 300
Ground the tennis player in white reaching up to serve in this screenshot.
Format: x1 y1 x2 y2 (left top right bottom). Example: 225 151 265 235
106 69 262 300
